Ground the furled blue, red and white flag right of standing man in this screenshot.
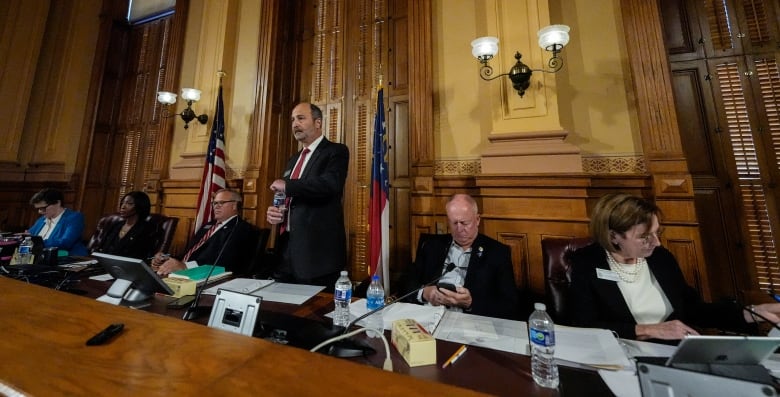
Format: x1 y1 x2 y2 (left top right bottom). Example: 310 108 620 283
368 85 390 291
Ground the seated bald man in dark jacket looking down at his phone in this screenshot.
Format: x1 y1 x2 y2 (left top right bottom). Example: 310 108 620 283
405 194 519 320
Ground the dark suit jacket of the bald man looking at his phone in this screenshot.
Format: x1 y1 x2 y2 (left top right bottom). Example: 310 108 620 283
405 234 519 320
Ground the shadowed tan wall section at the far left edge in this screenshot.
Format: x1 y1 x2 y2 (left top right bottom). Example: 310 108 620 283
0 0 101 181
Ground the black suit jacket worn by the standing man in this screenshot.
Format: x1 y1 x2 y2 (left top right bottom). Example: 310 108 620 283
283 138 349 279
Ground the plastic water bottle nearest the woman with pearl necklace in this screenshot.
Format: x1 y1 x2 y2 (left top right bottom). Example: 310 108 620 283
528 303 558 388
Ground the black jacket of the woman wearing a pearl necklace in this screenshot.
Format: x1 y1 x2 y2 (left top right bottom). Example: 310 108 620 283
568 243 750 339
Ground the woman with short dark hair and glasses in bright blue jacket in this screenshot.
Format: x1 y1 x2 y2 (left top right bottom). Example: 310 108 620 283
27 189 87 255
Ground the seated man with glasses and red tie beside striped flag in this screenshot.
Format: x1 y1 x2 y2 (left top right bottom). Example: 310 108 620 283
152 189 260 276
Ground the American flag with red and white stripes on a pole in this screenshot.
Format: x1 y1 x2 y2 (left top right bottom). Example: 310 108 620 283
195 84 225 232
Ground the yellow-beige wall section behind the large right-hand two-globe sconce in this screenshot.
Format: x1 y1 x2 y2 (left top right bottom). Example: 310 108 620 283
433 0 641 160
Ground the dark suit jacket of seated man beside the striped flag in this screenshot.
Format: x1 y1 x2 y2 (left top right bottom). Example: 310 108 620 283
184 216 260 276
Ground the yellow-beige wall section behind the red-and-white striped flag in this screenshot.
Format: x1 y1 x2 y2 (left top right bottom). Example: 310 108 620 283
170 0 260 179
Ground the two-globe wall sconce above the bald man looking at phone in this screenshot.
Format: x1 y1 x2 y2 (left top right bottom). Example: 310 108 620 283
471 25 569 98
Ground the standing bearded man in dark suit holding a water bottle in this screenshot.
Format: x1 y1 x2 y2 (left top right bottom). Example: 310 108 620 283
266 103 349 289
